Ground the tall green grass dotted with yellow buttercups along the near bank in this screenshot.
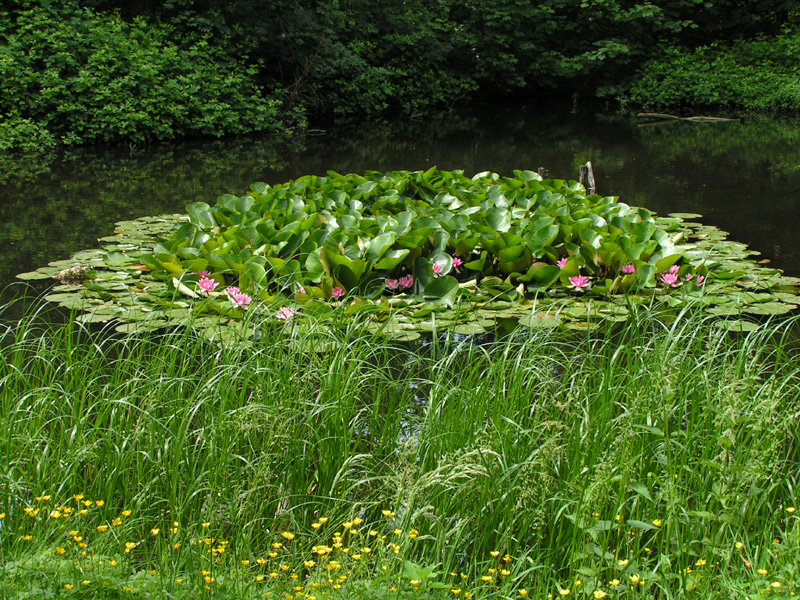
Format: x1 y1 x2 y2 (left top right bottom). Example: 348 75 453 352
0 298 800 600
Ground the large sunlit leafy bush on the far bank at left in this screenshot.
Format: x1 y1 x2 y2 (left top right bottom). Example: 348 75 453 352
0 3 304 149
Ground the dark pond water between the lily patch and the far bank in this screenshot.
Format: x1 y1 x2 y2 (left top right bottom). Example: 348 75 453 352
0 106 800 300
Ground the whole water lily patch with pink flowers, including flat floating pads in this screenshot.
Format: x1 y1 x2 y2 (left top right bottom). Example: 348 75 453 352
20 168 800 338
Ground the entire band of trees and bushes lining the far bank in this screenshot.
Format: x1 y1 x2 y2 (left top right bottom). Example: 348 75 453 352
0 0 798 144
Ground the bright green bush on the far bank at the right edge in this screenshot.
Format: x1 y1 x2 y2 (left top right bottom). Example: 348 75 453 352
619 32 800 112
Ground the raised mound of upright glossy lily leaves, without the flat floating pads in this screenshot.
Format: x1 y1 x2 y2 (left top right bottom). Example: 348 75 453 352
141 169 708 308
